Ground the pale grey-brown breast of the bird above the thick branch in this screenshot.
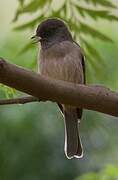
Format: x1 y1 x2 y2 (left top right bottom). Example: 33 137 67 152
39 41 84 83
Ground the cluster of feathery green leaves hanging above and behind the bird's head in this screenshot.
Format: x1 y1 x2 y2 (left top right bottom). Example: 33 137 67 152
13 0 118 80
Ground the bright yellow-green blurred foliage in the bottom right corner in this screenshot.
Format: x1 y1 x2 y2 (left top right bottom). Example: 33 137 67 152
76 165 118 180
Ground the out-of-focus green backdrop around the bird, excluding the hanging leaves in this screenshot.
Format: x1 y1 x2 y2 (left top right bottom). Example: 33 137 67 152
0 0 118 180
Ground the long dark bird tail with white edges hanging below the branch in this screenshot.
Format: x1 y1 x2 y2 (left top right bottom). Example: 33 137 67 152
64 109 83 159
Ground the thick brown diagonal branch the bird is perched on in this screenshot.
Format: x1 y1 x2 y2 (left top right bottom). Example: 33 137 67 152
0 57 118 116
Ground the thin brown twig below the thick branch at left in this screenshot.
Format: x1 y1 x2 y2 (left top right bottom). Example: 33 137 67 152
0 96 39 105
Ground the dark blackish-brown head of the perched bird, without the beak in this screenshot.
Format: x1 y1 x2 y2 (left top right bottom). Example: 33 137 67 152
36 19 72 49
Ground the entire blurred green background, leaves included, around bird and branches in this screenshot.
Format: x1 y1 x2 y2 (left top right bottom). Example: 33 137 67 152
0 0 118 180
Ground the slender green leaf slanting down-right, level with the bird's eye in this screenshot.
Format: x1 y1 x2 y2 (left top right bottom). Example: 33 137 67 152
79 22 113 42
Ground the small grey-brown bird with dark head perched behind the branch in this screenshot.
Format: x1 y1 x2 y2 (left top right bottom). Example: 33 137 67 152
32 18 85 159
